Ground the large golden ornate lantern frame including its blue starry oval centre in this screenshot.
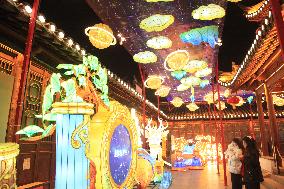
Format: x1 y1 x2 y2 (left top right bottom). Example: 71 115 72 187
89 101 139 189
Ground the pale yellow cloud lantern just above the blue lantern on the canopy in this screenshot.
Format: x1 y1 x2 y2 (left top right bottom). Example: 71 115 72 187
192 4 226 20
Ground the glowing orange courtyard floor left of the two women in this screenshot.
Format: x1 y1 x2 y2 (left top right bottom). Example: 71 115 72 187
171 165 231 189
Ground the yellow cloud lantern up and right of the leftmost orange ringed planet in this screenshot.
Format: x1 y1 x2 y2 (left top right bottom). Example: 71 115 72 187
139 14 175 32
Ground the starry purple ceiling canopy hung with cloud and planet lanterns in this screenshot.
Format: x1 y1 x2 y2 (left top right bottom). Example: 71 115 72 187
87 0 250 111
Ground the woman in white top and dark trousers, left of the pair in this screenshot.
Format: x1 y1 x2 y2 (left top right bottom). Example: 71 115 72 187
225 138 244 189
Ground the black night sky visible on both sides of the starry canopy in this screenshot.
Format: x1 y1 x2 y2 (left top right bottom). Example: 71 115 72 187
26 0 261 103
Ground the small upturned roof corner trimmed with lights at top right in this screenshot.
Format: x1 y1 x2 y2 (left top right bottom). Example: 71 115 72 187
241 0 270 22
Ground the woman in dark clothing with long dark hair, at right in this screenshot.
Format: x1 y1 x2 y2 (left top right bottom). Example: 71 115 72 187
243 136 263 189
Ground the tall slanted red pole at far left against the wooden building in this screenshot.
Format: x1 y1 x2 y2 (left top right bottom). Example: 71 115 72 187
14 0 40 142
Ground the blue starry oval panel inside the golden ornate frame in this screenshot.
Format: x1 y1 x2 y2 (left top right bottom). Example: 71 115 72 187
109 125 132 186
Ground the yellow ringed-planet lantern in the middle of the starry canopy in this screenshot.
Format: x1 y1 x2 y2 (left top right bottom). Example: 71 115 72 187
164 50 189 71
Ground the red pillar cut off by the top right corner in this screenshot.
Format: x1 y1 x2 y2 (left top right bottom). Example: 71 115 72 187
270 0 284 58
